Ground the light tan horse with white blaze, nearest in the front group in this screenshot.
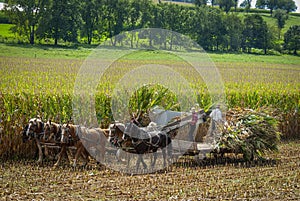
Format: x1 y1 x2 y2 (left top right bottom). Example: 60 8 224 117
55 124 107 167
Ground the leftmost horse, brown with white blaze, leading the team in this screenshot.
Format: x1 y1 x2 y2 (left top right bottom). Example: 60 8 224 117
21 118 44 163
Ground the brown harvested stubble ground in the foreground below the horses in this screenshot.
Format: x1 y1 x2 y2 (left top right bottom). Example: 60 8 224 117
0 141 300 200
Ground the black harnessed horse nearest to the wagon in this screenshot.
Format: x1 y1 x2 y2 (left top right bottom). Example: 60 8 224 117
122 123 172 169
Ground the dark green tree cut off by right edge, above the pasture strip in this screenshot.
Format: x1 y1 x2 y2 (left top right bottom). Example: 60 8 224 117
284 25 300 55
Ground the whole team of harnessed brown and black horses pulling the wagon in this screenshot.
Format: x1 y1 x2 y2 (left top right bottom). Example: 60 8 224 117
22 118 172 169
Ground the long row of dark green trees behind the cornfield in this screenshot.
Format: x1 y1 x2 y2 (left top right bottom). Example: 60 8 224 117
6 0 299 53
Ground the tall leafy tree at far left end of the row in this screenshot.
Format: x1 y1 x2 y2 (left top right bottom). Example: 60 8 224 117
5 0 49 44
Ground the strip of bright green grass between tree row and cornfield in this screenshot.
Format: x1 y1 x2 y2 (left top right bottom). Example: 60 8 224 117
0 43 300 64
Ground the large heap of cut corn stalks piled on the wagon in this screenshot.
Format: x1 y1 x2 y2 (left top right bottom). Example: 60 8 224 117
216 108 280 160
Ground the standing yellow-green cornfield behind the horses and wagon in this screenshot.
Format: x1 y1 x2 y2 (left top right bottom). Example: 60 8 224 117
0 52 300 159
